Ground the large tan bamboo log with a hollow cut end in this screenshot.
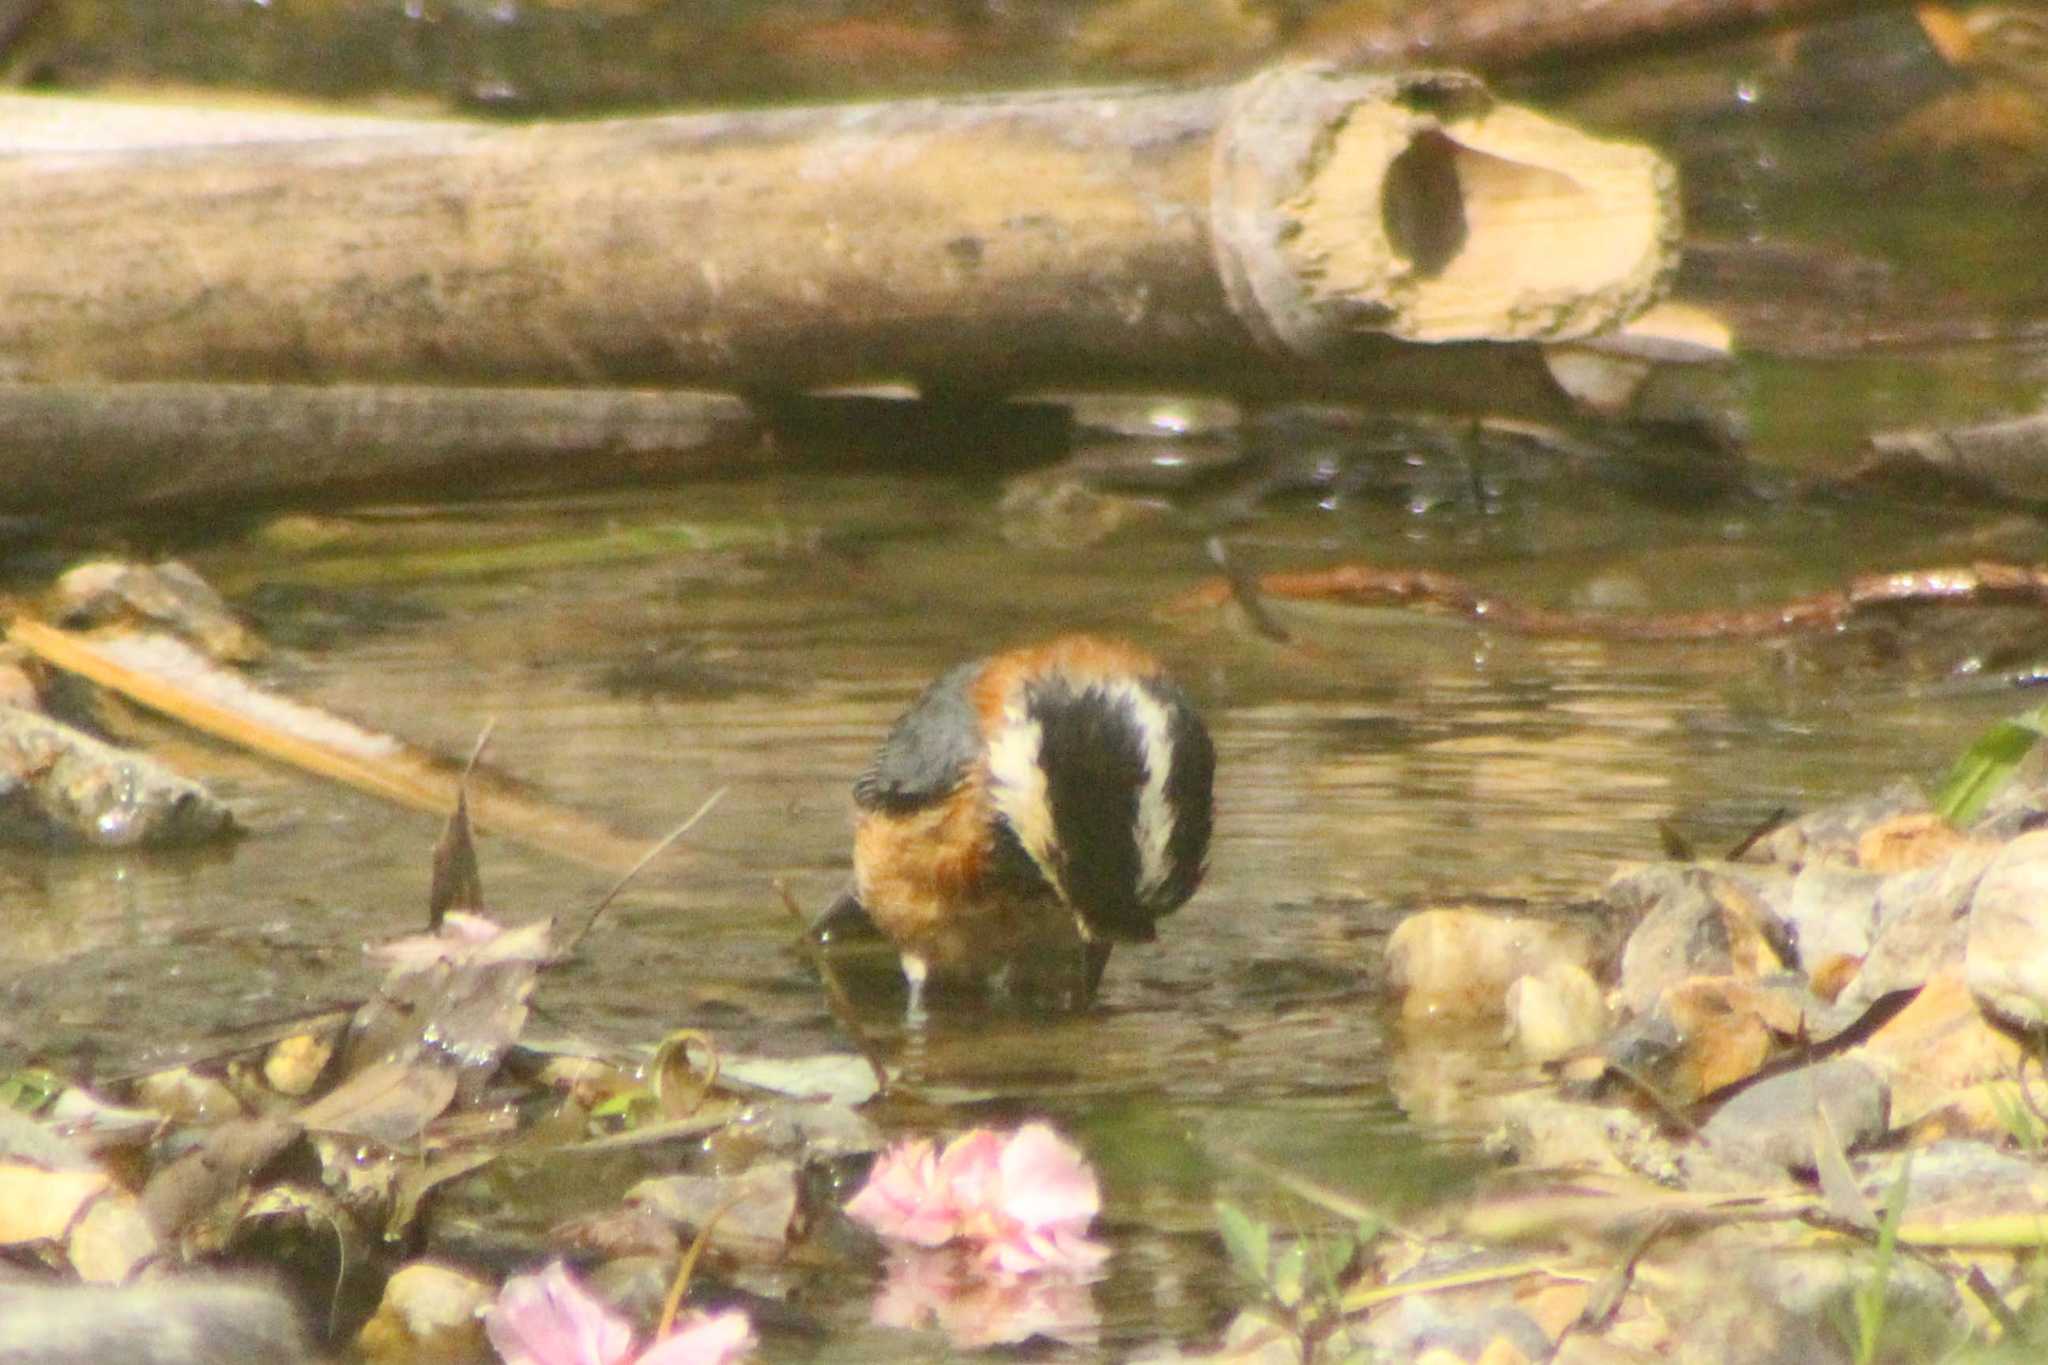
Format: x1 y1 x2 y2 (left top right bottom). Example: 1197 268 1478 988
0 68 1677 407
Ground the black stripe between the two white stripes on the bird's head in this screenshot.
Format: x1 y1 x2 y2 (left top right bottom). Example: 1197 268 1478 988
1026 679 1157 943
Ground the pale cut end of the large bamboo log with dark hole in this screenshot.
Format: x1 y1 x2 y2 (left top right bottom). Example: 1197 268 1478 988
1212 68 1679 354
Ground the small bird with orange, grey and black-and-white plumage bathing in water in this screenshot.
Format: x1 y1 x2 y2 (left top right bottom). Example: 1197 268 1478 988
842 636 1217 1015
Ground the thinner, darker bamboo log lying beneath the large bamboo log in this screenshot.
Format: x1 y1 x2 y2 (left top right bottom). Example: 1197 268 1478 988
0 383 760 516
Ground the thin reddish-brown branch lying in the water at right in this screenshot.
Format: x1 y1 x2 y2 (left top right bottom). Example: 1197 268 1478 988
1167 563 2048 641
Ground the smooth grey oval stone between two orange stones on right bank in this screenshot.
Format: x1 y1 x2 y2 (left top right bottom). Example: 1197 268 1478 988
1700 1058 1888 1171
